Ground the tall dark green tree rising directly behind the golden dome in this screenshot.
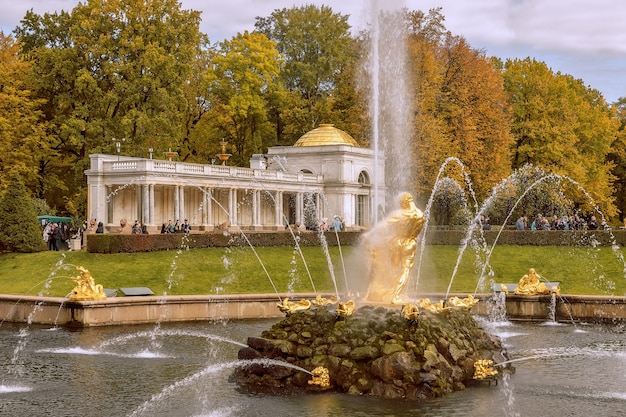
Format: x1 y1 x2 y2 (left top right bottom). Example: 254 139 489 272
255 4 354 145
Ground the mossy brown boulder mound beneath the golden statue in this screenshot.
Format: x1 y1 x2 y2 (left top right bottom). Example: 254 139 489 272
234 306 507 400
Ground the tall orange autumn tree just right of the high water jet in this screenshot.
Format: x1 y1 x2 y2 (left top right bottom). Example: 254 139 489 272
408 9 512 205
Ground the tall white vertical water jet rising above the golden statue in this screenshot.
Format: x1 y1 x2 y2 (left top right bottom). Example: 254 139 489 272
365 0 414 223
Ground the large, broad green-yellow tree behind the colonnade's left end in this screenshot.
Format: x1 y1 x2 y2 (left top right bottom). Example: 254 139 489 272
15 0 202 211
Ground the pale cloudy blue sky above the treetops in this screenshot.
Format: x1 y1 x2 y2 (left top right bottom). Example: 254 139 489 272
0 0 626 102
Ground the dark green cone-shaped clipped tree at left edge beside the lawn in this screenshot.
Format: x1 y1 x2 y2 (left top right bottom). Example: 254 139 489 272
0 175 45 253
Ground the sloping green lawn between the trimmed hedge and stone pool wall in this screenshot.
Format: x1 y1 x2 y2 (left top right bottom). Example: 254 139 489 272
0 246 626 296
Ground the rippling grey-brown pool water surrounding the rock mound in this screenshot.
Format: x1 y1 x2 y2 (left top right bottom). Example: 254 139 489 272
0 320 626 417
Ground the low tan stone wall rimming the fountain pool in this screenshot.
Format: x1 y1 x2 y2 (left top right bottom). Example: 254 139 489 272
0 293 626 327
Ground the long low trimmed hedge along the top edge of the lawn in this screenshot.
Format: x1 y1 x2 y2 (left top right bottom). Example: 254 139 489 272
87 230 626 253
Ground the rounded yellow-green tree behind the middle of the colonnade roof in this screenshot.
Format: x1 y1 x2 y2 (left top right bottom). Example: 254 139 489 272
206 31 283 164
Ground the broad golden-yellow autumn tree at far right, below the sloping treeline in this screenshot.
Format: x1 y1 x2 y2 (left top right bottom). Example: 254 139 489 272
504 58 619 217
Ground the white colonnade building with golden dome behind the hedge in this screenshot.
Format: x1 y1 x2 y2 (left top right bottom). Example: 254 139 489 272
85 124 385 233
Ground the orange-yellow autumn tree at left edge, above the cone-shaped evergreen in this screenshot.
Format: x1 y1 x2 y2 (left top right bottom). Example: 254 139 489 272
0 32 49 195
